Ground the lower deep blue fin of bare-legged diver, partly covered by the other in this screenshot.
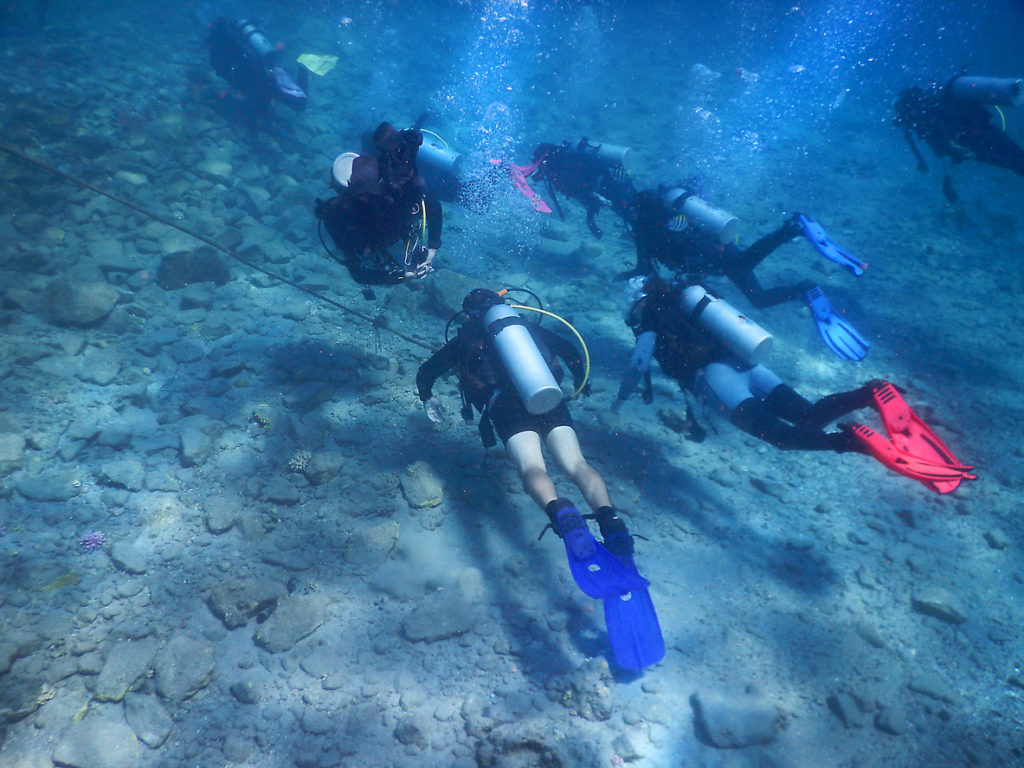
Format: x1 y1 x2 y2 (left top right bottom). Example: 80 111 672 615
604 527 665 670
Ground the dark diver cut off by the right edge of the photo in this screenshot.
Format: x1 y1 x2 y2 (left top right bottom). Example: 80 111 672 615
893 73 1024 185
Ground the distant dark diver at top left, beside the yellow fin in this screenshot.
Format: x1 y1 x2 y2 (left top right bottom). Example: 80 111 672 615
207 16 308 115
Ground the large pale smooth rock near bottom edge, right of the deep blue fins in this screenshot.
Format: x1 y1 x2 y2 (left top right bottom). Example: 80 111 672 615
690 691 785 749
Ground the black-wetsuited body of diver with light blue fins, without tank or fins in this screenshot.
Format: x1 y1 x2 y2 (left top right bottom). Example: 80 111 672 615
618 186 814 308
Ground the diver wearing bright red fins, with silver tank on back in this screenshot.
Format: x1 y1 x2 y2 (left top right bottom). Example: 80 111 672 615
611 278 975 494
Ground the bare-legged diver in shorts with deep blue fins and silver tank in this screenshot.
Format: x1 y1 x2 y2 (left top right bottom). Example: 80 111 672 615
416 288 665 669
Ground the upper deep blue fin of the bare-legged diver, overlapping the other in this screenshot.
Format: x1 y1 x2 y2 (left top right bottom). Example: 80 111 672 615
555 505 650 600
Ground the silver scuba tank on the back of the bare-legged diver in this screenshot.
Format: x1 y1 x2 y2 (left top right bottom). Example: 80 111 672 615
483 304 562 416
